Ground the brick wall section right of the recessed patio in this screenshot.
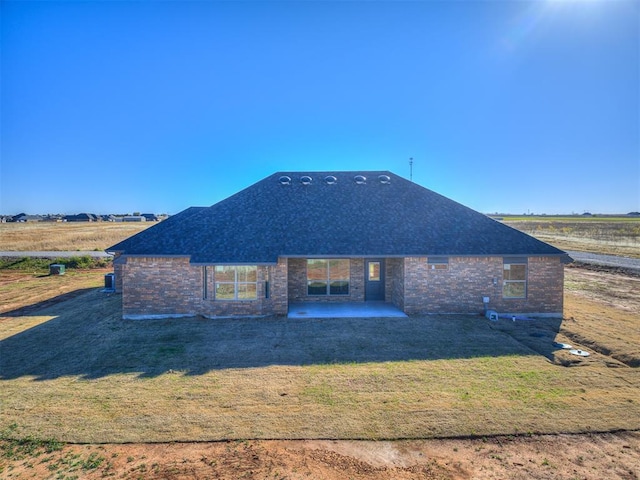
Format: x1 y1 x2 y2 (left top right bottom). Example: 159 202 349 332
404 257 564 314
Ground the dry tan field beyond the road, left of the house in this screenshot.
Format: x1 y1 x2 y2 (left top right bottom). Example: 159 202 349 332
0 222 152 251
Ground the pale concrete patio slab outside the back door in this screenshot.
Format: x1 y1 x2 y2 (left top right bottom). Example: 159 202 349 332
288 302 407 318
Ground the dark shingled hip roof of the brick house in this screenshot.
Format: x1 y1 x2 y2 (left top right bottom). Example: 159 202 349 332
107 171 564 264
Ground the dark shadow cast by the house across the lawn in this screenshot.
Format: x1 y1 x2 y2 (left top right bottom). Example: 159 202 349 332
0 289 561 380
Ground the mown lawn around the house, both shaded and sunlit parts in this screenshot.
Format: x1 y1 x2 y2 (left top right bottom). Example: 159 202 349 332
0 266 640 443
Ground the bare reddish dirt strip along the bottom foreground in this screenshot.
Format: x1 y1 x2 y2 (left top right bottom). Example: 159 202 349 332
0 432 640 480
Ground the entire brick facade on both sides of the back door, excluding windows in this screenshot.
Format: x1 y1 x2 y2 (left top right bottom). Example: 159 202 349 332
114 257 564 318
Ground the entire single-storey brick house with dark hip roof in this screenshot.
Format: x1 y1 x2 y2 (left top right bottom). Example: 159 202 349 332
107 171 570 318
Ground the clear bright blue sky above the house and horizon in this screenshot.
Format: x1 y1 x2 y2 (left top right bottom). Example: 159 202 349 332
0 0 640 214
